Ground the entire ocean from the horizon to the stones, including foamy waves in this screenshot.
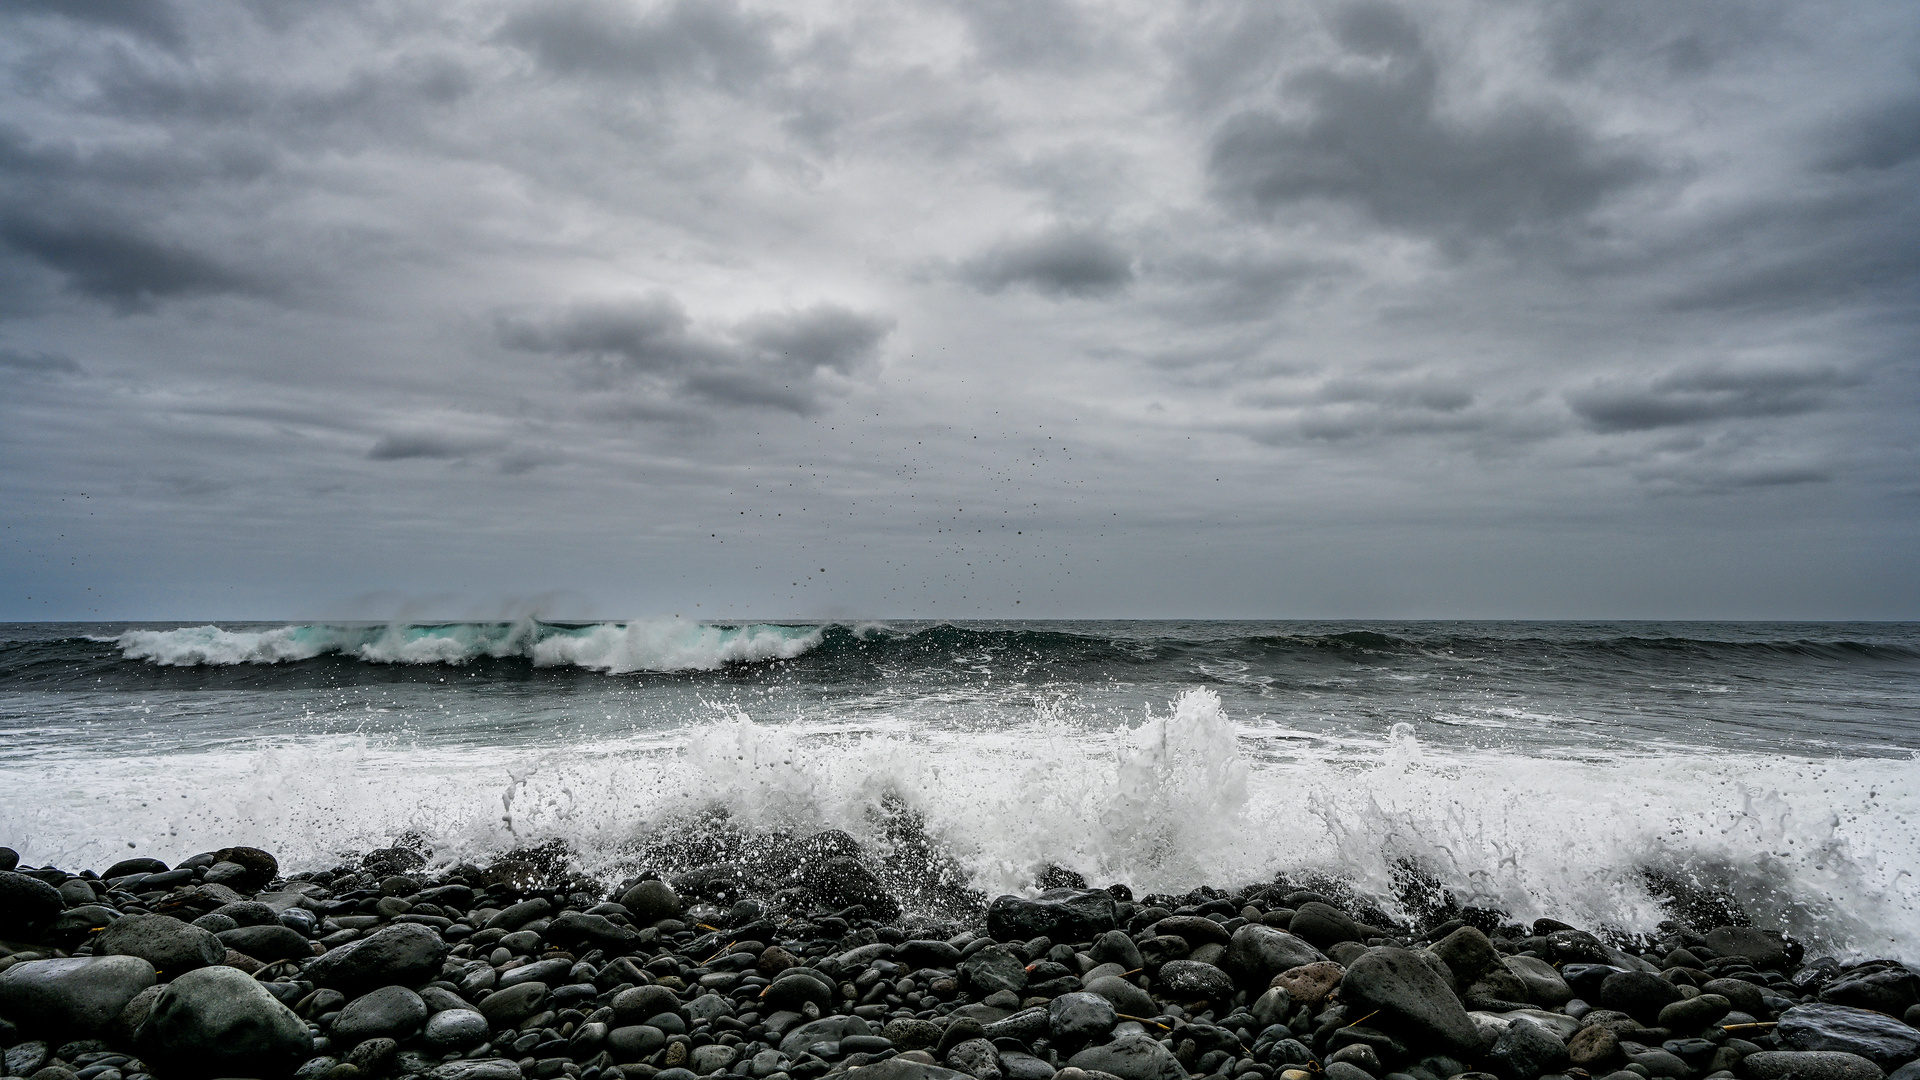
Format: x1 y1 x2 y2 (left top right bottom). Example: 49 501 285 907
0 621 1920 961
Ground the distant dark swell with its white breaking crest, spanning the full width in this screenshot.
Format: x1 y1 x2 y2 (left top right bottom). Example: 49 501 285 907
0 621 1920 690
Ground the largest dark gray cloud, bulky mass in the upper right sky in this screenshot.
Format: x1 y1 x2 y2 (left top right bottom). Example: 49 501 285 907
1208 2 1655 238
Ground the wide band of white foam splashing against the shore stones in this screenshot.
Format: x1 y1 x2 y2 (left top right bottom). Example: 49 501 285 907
0 684 1920 959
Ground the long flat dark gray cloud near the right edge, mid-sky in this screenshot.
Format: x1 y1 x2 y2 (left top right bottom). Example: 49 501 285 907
1567 367 1851 432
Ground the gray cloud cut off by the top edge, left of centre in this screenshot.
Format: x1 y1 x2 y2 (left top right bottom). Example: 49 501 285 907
499 0 776 90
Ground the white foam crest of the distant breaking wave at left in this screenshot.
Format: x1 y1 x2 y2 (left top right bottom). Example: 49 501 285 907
113 619 824 673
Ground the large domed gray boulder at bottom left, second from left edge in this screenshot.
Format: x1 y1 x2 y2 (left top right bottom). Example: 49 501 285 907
138 967 313 1076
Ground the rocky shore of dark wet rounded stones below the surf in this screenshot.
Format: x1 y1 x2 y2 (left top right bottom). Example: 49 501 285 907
0 834 1920 1080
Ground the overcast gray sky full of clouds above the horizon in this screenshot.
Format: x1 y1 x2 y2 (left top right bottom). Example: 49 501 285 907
0 0 1920 621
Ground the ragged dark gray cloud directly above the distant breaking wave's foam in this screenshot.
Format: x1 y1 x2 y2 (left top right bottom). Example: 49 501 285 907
499 292 893 419
